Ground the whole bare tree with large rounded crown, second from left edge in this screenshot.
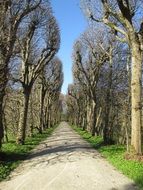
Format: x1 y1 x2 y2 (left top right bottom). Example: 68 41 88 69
15 7 60 144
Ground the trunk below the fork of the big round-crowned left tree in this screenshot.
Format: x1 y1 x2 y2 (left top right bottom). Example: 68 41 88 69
17 90 30 145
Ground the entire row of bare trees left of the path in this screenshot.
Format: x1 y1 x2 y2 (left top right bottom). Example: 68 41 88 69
0 0 63 147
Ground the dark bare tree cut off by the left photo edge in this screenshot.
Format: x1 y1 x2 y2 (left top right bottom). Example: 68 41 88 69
0 0 42 147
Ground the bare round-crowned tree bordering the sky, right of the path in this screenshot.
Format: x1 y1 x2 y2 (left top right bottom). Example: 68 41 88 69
73 28 109 135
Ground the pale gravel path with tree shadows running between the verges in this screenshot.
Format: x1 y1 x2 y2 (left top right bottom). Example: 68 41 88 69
0 122 137 190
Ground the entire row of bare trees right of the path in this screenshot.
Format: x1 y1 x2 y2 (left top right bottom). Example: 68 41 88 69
66 0 143 155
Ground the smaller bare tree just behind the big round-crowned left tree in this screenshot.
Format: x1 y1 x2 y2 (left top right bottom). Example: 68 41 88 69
39 57 63 133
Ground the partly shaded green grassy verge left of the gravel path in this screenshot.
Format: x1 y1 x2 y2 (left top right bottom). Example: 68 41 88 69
0 126 57 181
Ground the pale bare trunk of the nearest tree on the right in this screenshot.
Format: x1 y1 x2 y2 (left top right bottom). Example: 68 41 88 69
131 42 142 154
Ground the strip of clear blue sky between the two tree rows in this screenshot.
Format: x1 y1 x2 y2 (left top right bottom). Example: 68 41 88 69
51 0 87 94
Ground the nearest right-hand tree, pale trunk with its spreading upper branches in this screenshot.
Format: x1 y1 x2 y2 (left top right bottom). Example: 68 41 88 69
82 0 143 154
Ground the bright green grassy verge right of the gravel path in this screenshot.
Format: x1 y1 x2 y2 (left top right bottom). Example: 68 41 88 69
72 127 143 190
